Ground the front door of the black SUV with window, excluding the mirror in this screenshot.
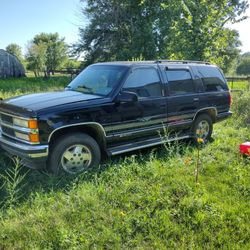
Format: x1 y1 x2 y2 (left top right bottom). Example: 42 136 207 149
112 66 167 141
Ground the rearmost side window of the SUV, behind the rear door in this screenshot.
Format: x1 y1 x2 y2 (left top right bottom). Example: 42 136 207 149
197 66 228 92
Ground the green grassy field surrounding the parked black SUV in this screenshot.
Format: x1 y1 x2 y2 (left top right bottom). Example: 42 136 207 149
0 77 250 249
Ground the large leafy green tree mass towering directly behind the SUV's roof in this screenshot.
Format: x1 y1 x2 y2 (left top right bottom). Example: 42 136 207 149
75 0 248 71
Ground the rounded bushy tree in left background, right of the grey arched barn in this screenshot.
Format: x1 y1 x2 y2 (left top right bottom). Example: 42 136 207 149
27 33 67 76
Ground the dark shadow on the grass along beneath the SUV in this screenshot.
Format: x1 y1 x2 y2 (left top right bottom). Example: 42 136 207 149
0 140 199 208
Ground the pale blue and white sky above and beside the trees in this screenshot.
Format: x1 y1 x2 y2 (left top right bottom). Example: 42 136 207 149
0 0 250 53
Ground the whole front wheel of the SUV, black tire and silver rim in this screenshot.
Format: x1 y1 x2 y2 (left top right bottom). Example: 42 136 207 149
47 133 101 175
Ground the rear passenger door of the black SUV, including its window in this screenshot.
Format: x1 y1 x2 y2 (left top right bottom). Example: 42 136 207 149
165 67 199 130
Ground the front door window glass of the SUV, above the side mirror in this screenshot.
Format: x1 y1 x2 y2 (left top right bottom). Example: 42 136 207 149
123 68 162 97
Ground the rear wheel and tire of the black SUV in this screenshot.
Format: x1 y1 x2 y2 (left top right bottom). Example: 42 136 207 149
192 114 213 142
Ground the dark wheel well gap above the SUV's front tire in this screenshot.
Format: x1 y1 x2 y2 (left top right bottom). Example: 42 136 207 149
49 125 106 150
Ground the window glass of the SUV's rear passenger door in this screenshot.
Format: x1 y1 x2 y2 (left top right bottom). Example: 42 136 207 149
166 70 195 95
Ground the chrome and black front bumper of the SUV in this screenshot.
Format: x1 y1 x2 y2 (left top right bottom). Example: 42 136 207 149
0 134 49 169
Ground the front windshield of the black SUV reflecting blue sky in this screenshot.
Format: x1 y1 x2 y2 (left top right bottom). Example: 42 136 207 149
66 65 127 96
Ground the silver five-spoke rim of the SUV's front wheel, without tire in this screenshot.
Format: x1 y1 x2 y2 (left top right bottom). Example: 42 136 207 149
61 144 92 174
